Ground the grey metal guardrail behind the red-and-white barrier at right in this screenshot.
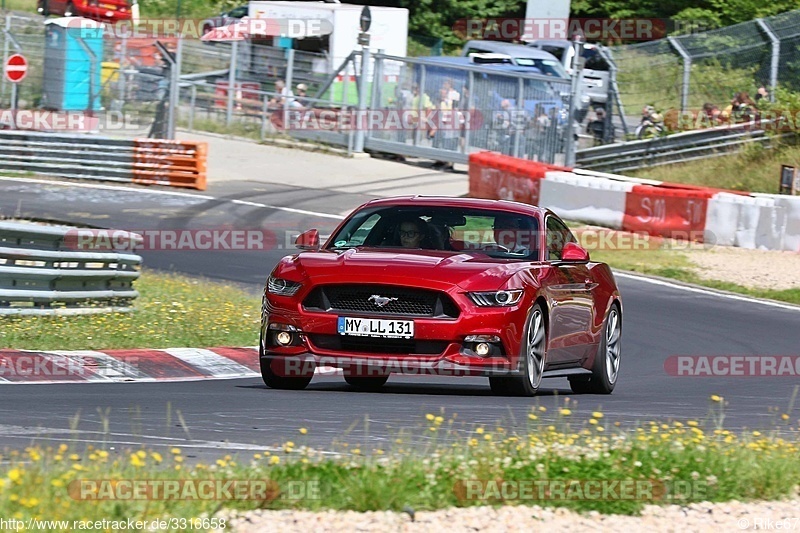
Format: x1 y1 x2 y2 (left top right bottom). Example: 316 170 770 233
576 124 793 172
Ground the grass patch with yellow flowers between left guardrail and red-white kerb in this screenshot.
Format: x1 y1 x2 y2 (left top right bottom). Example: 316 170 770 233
0 270 261 350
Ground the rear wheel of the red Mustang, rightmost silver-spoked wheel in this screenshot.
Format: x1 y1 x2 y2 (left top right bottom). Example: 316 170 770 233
569 304 622 394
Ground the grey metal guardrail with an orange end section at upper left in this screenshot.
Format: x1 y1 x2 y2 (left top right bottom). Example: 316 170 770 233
0 131 207 190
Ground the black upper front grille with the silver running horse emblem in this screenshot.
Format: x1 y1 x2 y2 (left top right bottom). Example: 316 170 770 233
303 285 459 318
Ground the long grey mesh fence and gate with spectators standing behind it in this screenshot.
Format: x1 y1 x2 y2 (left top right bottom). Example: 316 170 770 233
0 15 574 163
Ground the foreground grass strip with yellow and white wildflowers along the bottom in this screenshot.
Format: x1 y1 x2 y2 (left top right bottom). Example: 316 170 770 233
0 400 800 530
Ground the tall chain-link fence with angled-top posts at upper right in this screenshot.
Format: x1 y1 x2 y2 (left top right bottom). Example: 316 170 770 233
608 10 800 119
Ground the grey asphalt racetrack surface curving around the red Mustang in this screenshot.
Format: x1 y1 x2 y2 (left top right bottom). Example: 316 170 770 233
0 177 800 457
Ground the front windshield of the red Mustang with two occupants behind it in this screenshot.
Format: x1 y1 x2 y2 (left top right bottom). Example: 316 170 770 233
326 206 539 261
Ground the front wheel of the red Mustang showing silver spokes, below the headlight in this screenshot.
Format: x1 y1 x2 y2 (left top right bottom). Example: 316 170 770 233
489 304 547 396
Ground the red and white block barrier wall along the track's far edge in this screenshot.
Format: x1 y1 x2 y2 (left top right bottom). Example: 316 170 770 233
469 152 800 251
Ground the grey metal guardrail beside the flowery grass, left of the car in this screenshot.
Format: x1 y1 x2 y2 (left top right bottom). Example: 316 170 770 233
0 221 142 316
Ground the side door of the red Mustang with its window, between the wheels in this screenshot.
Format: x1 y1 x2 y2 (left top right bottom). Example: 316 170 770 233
545 215 594 366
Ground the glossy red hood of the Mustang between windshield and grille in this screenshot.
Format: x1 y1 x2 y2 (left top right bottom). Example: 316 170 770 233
275 248 539 290
